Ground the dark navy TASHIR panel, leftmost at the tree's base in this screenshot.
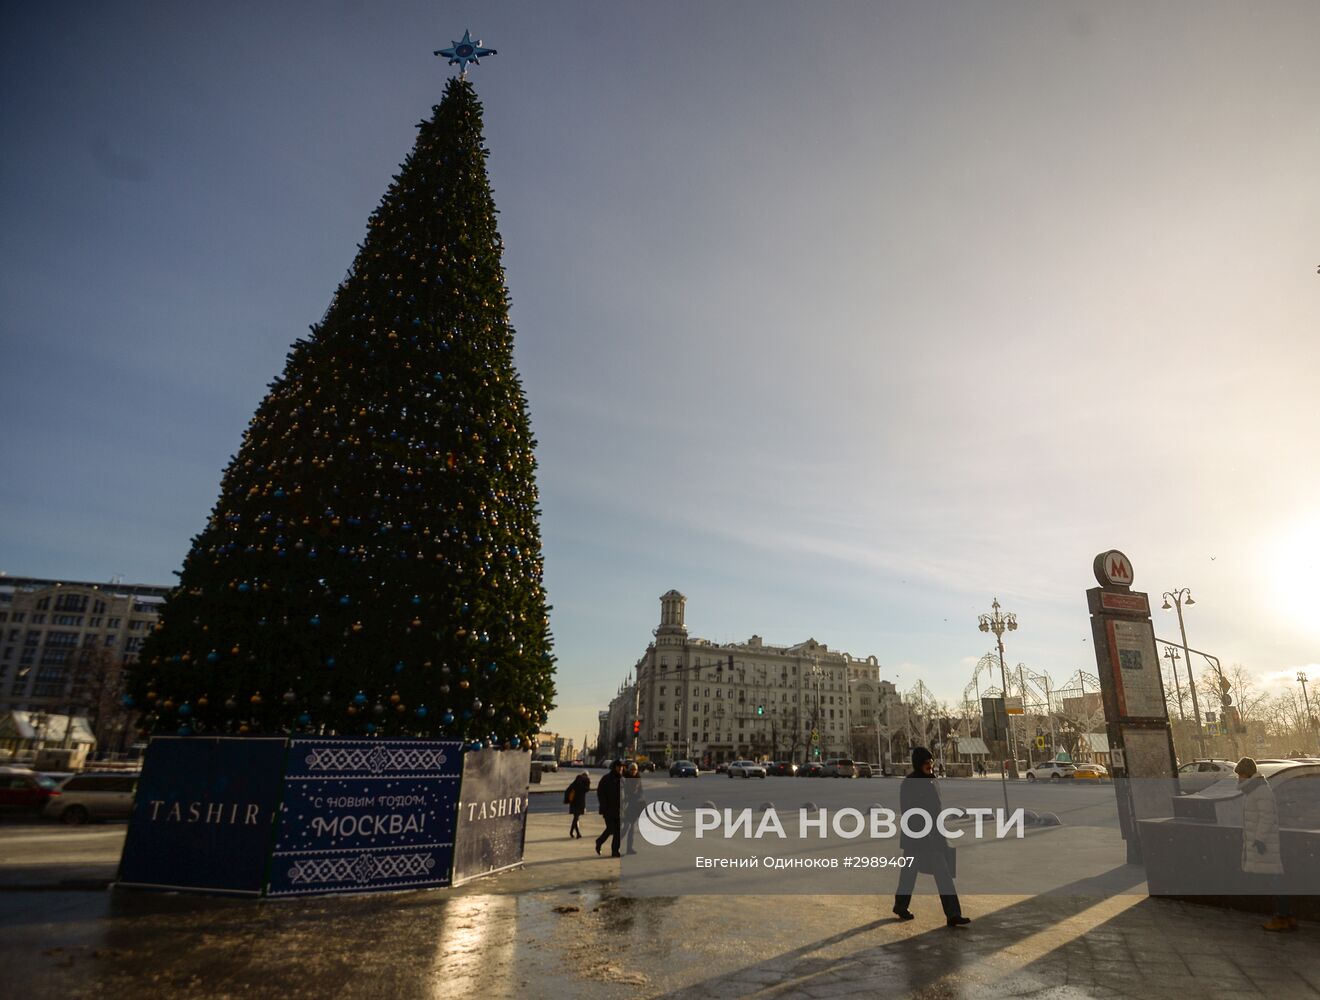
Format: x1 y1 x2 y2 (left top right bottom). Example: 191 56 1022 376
119 736 285 896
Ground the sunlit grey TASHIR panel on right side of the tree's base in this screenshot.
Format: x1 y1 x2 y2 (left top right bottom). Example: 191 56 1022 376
454 749 531 885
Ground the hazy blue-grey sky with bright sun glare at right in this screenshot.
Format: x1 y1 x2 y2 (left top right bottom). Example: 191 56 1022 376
0 0 1320 737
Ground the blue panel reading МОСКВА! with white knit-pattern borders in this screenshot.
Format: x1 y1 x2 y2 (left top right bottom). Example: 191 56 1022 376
267 739 463 896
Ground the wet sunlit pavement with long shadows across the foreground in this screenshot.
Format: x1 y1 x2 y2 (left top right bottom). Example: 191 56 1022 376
0 786 1320 1000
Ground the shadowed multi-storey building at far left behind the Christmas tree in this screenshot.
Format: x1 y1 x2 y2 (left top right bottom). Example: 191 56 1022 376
0 577 169 751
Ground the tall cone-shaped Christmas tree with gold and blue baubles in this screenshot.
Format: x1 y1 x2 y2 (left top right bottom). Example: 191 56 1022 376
128 78 554 747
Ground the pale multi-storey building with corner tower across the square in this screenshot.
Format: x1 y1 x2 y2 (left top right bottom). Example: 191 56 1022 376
602 590 892 765
